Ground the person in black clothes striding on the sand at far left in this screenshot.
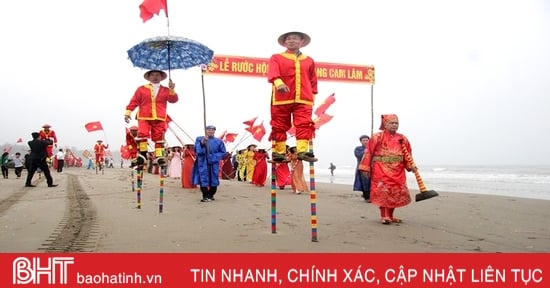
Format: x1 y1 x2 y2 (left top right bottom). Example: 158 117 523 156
25 132 57 187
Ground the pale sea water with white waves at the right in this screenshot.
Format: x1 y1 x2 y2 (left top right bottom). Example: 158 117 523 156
310 164 550 200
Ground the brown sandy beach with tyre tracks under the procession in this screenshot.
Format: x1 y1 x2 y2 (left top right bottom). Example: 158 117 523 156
0 168 550 252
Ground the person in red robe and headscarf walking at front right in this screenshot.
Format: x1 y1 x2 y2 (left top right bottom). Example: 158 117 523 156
359 114 417 224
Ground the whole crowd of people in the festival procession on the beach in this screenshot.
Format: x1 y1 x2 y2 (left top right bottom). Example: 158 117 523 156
0 31 417 224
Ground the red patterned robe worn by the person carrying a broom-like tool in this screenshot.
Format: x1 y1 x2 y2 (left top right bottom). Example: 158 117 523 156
359 130 411 208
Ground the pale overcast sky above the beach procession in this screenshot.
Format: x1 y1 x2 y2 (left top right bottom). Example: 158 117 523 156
0 0 550 168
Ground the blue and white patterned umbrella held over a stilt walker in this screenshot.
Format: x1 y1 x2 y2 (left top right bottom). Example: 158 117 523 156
128 36 214 71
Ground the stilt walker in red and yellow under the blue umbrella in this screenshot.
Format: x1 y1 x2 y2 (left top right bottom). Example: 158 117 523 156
124 70 179 166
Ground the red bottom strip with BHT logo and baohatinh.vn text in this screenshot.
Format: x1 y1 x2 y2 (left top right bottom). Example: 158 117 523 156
0 253 550 287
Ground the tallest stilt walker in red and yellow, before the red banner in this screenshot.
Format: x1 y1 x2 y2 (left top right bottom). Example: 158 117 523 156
267 31 317 162
